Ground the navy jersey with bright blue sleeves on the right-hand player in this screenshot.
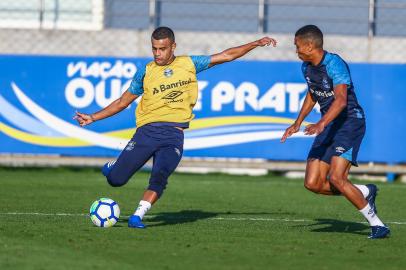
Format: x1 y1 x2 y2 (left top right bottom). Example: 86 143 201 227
302 51 365 118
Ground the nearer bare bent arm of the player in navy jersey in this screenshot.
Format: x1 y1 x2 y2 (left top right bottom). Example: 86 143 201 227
304 84 347 135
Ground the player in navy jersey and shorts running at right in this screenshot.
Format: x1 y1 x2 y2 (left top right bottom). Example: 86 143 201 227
281 25 390 239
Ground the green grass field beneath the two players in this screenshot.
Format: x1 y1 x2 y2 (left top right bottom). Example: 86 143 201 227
0 168 406 270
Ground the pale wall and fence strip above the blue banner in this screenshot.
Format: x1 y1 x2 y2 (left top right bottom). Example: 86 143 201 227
0 0 406 63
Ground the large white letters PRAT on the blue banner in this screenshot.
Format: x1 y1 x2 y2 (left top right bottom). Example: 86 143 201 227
211 81 307 112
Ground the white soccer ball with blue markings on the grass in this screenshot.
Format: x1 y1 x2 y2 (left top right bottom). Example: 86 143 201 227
90 198 120 228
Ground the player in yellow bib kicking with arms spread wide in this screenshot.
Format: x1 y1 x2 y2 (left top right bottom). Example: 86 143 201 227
74 27 276 228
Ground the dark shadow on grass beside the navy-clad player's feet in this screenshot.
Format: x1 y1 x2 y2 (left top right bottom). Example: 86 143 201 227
306 218 369 235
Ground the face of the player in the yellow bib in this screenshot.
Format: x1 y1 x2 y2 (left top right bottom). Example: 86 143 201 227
151 38 176 66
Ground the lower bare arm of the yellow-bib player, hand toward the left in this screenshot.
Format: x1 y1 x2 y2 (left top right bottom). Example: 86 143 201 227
73 90 138 127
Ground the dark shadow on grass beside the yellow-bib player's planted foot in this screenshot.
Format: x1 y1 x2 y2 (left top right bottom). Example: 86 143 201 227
145 210 218 227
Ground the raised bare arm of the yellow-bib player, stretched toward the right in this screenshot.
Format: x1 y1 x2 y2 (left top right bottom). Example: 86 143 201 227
209 37 276 67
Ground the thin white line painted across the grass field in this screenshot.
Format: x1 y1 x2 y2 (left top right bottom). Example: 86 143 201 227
0 212 406 225
